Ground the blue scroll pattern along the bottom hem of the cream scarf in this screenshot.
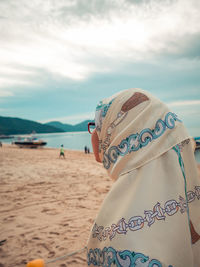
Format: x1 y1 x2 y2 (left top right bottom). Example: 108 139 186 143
87 247 172 267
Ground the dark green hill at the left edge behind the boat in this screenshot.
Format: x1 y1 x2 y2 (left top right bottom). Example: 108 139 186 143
0 116 64 135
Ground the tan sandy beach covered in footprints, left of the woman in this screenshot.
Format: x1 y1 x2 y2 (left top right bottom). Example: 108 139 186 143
0 145 112 267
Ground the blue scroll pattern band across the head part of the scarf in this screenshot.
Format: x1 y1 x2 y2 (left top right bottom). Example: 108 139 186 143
103 112 182 169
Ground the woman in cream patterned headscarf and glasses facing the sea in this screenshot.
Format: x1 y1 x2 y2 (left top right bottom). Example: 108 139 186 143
87 89 200 267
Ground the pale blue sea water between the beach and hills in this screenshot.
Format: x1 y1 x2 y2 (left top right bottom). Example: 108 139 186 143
0 132 200 163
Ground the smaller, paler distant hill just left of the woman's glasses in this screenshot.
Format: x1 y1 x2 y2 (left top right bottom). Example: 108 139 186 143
46 120 92 132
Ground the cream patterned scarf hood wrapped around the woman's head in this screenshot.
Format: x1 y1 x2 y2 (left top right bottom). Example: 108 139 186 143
95 88 189 180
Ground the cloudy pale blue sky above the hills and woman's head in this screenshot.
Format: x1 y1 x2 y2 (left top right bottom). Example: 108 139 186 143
0 0 200 136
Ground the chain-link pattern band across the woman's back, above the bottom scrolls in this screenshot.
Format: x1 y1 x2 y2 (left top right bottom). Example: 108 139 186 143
92 186 200 242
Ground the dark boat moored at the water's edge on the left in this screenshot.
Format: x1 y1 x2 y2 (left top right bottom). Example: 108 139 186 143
13 137 47 148
